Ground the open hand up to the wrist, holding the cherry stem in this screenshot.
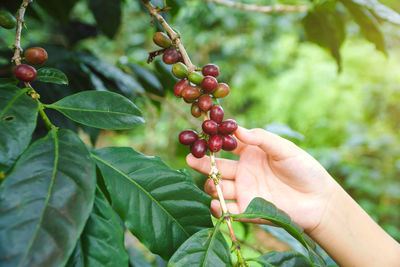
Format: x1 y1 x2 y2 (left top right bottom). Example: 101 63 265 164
186 127 339 232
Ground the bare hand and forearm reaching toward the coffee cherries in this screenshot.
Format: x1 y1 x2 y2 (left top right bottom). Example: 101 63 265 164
186 127 400 267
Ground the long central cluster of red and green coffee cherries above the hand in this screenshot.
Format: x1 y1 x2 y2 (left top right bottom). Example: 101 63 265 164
153 32 238 158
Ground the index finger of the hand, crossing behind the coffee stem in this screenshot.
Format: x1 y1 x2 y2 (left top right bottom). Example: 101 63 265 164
186 154 237 180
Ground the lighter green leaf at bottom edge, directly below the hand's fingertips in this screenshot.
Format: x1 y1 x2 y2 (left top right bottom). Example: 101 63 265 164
168 223 233 267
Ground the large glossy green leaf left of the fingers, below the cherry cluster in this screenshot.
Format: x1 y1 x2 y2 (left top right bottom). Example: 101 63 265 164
92 147 212 259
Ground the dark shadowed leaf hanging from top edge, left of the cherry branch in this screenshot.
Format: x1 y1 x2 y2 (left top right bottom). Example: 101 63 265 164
89 0 122 38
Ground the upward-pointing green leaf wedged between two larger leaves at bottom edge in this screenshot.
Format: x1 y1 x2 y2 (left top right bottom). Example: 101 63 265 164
68 189 128 267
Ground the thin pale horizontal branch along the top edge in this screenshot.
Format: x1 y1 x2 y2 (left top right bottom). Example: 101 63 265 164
203 0 308 14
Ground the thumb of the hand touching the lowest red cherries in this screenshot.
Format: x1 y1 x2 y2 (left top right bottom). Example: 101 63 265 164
235 127 301 160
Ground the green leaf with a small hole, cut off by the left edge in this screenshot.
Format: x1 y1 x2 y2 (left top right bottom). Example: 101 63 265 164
0 84 38 173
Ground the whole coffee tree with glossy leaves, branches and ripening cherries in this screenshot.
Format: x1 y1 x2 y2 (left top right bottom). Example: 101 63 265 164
0 0 400 266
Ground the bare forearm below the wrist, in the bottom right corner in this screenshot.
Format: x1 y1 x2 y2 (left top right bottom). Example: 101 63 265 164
310 185 400 267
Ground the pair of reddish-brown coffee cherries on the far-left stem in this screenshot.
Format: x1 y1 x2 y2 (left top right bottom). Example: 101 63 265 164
14 47 48 82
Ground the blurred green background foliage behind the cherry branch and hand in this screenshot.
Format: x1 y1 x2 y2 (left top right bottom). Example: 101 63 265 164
0 0 400 266
